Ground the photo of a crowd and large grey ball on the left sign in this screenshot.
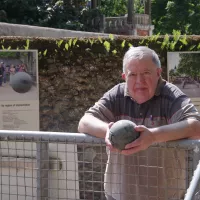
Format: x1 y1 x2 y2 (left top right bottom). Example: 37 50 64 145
0 51 39 101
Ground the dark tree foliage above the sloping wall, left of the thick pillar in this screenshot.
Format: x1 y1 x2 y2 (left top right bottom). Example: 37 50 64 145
0 0 144 31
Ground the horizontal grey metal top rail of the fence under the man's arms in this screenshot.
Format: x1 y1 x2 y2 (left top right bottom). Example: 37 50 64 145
0 130 200 149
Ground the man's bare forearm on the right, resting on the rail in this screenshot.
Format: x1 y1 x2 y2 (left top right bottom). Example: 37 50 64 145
152 119 200 143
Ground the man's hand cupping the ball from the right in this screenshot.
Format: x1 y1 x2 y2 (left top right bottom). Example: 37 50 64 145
121 125 155 155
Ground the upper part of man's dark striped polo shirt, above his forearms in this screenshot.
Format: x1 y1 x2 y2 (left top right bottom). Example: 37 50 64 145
86 79 199 128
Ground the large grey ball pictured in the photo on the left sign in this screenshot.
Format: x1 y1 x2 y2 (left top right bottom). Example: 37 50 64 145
10 72 33 93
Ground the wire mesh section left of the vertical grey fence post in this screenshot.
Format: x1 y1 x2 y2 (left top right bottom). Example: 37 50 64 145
0 141 37 200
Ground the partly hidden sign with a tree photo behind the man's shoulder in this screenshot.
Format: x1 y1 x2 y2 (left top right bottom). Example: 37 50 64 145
167 51 200 111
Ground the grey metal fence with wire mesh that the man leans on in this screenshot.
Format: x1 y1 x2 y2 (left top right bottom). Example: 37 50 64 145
0 131 200 200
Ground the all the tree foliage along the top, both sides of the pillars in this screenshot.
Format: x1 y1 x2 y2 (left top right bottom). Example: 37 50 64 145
0 0 200 34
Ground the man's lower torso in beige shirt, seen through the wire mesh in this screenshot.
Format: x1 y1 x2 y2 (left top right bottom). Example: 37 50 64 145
103 147 192 200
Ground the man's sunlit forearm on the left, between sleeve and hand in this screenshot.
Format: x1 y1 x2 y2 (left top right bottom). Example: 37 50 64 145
78 114 108 138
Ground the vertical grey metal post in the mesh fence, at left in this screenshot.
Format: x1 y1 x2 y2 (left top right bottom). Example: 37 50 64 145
36 142 49 200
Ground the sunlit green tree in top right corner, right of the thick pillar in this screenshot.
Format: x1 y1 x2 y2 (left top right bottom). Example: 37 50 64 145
152 0 200 34
